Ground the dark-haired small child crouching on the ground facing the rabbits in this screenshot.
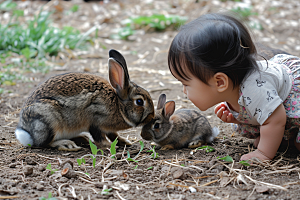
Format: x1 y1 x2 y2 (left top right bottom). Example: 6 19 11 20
168 14 300 160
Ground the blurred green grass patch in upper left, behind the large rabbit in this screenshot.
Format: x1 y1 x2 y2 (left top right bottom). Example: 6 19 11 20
0 0 90 94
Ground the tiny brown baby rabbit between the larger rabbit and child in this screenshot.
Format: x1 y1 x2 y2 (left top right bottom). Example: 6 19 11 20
141 94 219 150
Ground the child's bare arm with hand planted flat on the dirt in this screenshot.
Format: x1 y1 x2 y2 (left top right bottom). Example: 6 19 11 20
241 104 286 160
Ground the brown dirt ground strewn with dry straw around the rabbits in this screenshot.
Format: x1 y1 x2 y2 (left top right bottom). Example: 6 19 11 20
0 0 300 200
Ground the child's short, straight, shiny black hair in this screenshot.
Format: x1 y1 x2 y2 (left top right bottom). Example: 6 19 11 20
168 14 258 88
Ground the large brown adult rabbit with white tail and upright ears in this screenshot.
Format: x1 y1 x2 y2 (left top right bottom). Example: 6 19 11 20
15 50 154 151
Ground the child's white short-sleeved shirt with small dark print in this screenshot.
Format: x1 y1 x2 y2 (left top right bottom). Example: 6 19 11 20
228 61 293 125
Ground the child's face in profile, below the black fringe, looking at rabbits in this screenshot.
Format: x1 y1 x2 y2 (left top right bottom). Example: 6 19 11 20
178 75 219 111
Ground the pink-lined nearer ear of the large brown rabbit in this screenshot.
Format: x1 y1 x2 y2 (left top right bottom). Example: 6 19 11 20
108 58 129 100
